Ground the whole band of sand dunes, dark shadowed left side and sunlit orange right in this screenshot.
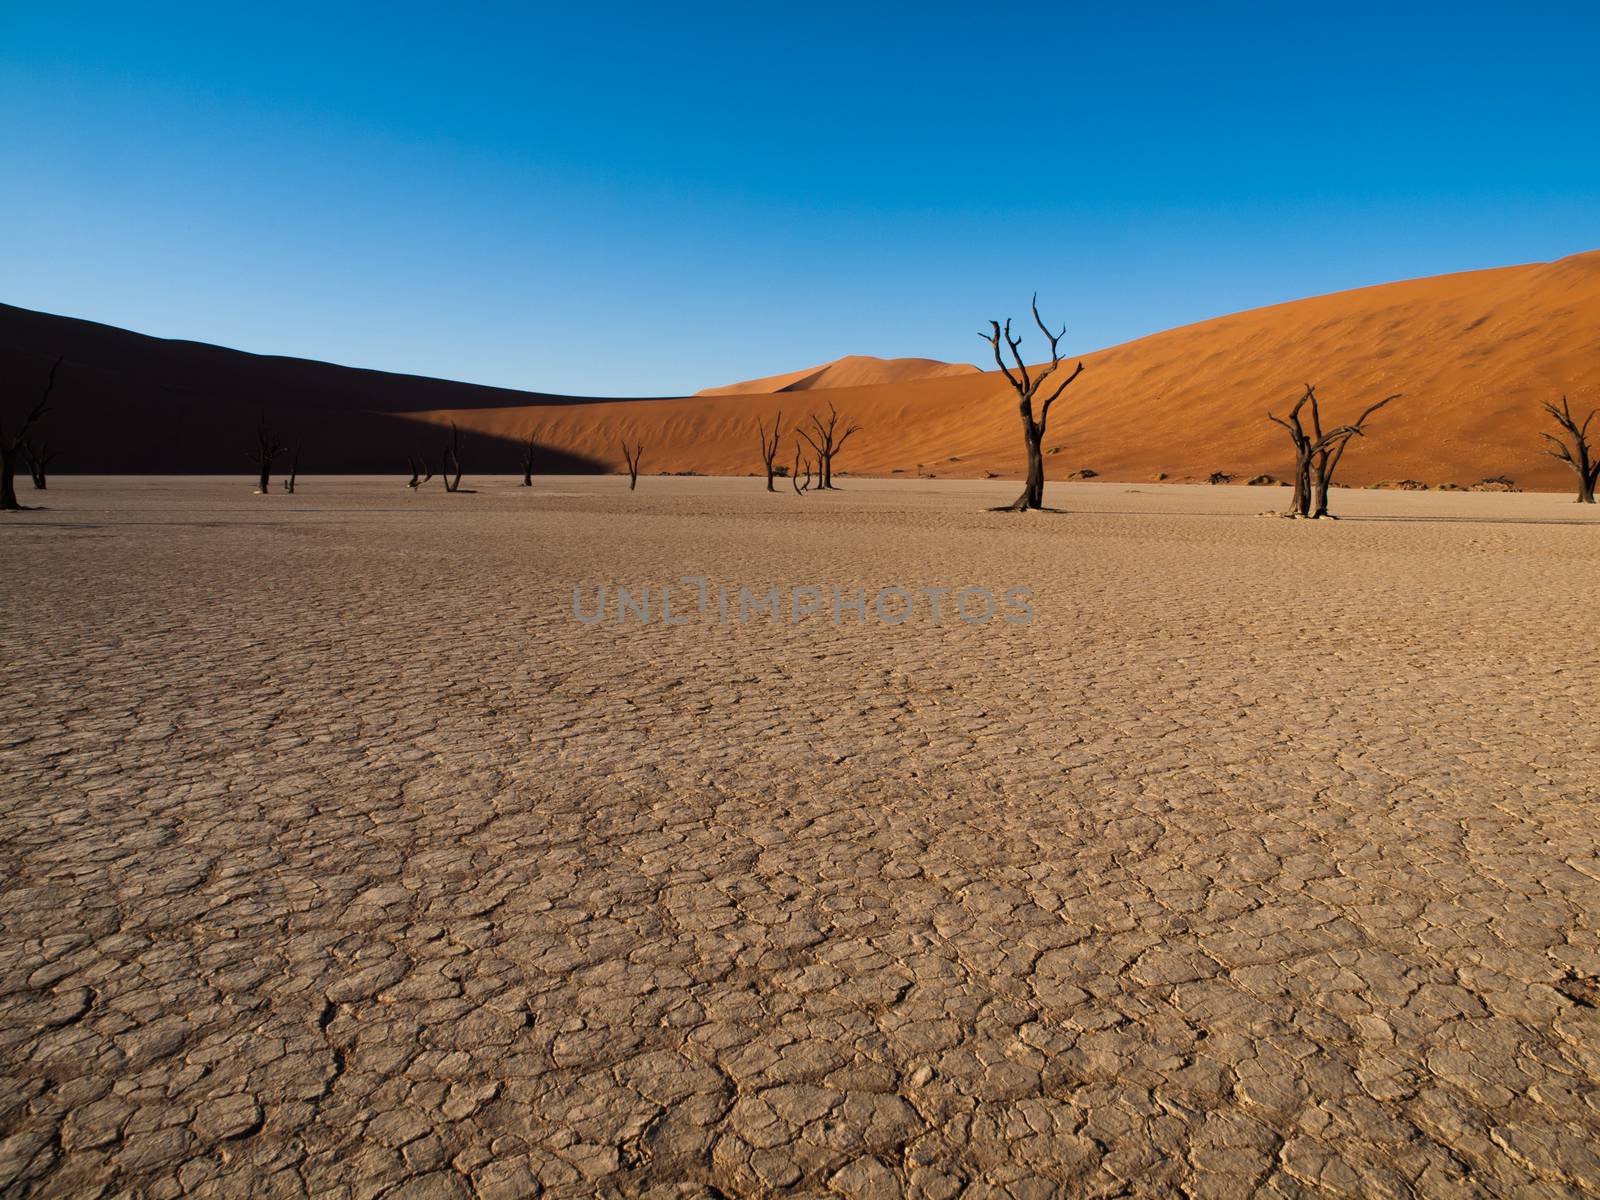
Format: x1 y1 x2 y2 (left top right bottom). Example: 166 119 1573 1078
0 251 1600 490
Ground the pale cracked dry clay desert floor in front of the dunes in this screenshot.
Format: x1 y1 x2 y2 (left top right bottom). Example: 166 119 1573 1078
0 477 1600 1200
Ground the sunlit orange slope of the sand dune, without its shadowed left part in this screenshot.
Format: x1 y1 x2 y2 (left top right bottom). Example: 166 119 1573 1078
416 251 1600 488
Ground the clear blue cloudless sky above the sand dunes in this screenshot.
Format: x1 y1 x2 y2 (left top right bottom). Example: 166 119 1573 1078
0 0 1600 395
